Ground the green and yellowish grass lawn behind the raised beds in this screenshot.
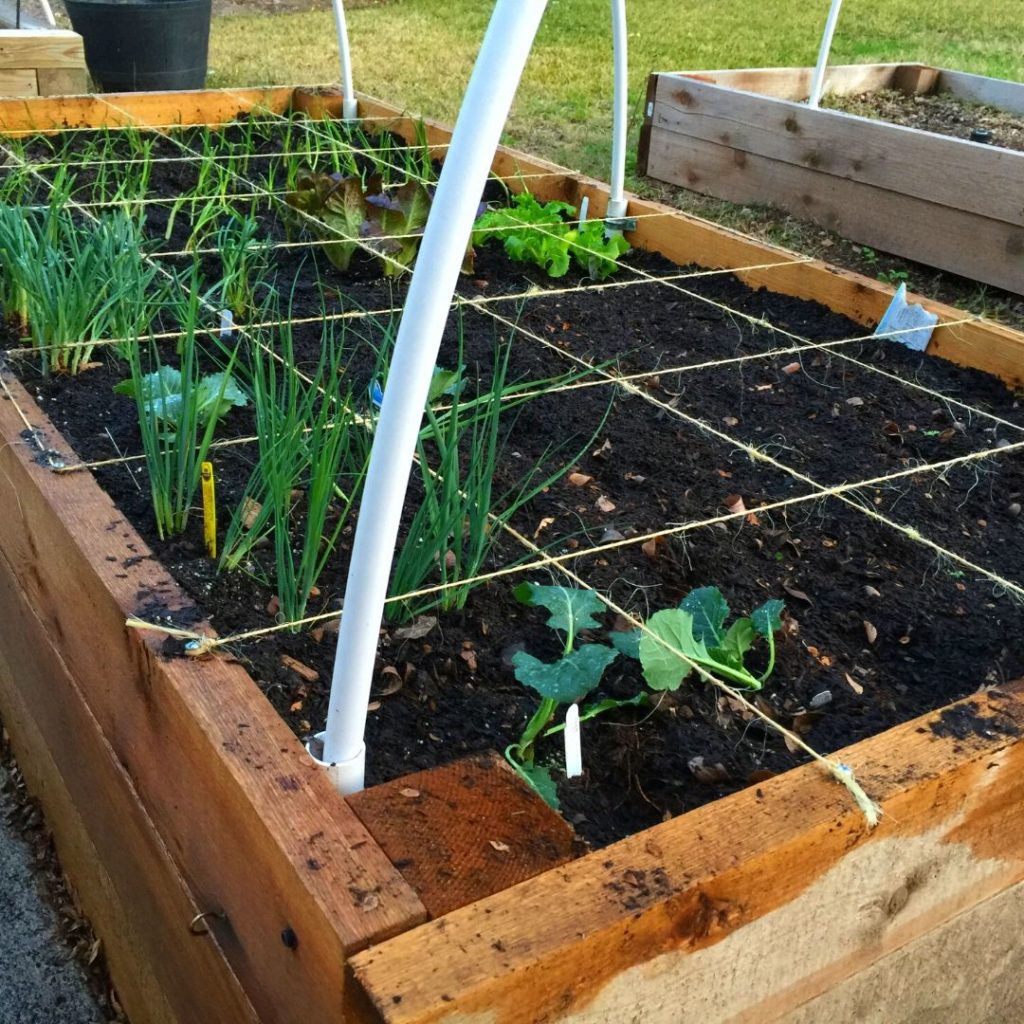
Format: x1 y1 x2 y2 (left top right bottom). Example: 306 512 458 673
210 0 1024 315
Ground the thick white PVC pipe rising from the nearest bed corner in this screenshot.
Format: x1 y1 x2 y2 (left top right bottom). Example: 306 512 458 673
310 0 548 793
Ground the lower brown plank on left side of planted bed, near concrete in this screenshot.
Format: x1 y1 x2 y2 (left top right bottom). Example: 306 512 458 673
0 557 256 1024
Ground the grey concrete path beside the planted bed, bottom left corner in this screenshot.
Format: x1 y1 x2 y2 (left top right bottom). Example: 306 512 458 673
0 765 103 1024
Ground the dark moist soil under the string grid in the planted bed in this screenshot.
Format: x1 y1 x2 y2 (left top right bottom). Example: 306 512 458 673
4 117 1024 844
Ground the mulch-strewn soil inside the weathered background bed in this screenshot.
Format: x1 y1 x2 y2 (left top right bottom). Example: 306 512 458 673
822 89 1024 151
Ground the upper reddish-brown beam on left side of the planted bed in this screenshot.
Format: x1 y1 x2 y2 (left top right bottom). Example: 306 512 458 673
0 370 425 1021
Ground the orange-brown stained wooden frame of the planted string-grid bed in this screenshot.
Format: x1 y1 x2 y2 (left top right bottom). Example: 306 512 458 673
0 89 1024 1024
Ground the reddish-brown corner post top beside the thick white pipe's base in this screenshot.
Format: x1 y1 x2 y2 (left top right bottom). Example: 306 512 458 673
347 755 574 918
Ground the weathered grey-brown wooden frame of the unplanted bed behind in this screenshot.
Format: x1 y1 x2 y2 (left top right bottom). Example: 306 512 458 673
638 63 1024 293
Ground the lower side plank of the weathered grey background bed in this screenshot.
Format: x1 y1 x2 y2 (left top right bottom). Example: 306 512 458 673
649 122 1024 292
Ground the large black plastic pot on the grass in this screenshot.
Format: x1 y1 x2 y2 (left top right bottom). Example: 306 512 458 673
65 0 211 92
